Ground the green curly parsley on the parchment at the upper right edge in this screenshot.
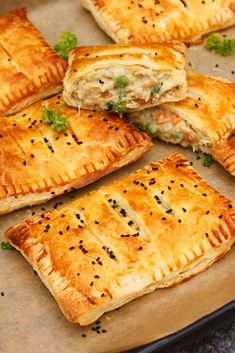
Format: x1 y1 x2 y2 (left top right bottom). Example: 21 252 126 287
205 33 235 56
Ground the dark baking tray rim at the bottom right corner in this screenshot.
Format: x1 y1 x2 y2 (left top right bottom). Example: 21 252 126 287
126 300 235 353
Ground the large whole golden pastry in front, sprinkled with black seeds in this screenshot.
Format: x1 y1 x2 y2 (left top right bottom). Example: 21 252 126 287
5 154 235 325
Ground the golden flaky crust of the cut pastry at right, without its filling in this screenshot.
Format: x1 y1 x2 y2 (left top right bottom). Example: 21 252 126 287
129 71 235 175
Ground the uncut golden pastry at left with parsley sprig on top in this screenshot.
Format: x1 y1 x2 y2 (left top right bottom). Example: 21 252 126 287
0 96 153 214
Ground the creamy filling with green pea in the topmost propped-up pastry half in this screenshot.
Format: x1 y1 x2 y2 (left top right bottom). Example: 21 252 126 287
74 66 184 114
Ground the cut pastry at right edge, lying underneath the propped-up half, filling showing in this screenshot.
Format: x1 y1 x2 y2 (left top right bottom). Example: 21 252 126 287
128 71 235 176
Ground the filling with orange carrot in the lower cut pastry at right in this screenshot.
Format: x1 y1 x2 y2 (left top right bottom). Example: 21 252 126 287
128 108 211 153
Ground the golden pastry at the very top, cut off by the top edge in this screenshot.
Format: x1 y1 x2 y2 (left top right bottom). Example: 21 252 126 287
81 0 235 44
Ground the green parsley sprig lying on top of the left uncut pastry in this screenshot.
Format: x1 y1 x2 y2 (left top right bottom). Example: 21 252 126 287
42 102 69 132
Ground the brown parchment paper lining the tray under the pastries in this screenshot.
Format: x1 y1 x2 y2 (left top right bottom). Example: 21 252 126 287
0 0 235 353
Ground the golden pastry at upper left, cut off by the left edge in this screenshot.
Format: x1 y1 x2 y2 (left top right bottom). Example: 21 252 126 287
0 8 67 116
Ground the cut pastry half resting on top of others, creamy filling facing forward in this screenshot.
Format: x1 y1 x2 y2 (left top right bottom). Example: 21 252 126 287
63 42 187 114
